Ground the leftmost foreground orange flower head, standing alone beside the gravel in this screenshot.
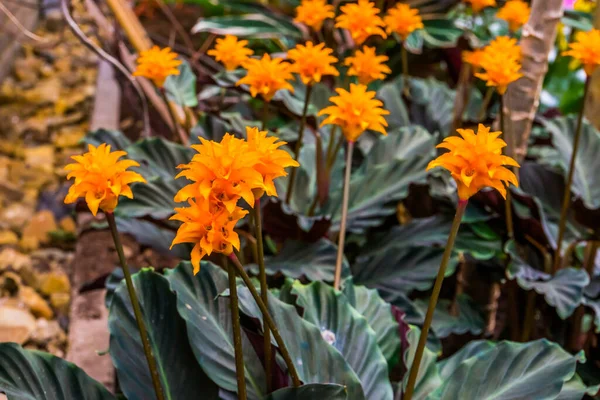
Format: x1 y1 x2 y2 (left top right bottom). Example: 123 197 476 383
65 143 146 216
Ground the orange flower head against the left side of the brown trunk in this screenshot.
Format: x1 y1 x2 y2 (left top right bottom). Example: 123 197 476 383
475 51 523 95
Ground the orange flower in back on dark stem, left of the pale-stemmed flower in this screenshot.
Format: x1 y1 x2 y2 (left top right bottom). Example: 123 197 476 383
287 42 340 85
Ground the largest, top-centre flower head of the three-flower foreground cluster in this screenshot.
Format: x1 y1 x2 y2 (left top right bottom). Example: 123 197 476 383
175 133 264 213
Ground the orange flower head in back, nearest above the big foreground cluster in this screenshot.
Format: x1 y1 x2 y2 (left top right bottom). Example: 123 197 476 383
236 54 294 101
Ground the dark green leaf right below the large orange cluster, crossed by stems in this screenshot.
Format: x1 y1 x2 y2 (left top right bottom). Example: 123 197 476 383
166 261 266 399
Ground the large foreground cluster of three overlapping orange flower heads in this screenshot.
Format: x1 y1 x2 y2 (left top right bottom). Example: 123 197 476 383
171 128 299 273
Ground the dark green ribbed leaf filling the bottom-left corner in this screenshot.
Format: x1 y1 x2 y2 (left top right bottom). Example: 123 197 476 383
0 343 115 400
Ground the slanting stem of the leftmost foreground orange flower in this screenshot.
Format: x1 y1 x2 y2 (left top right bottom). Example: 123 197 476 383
105 212 165 400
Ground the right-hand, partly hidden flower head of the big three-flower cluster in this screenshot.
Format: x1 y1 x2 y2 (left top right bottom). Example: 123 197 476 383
246 127 300 196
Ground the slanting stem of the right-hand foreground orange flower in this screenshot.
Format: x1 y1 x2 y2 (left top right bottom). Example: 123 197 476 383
403 200 468 400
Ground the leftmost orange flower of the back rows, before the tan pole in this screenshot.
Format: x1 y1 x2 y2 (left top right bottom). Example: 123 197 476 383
133 46 181 88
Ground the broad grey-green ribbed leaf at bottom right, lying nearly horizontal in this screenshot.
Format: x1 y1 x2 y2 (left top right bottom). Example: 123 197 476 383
431 339 578 400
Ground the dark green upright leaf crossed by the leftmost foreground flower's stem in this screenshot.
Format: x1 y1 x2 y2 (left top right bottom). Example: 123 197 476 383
108 269 218 400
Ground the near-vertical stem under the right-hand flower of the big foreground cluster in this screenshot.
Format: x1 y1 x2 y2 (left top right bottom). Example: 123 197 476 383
253 200 274 393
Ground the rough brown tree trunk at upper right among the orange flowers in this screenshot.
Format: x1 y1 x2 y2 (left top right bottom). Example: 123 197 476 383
505 0 563 161
